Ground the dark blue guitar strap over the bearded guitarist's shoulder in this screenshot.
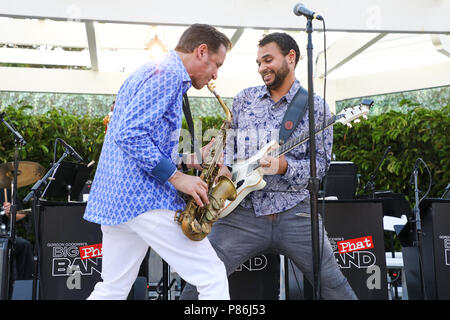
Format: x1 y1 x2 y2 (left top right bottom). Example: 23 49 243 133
279 87 308 145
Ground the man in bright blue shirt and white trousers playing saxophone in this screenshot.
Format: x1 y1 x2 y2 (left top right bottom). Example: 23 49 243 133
84 24 231 300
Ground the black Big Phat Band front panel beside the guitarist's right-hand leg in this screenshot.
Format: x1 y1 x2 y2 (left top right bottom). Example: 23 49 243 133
319 200 388 300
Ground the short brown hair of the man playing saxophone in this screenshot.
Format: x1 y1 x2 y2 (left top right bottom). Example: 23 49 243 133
175 23 233 53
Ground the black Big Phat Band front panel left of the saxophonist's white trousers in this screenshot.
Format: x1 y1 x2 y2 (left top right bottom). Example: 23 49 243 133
39 201 102 300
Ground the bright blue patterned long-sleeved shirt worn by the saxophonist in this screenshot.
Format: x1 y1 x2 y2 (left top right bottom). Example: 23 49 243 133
84 50 192 225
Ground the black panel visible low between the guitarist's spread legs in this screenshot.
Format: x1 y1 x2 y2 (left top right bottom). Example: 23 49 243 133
228 253 280 300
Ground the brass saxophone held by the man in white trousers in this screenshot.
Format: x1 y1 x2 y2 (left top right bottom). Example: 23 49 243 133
175 83 237 241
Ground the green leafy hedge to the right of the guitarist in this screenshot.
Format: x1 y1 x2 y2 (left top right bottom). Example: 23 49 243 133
333 105 450 204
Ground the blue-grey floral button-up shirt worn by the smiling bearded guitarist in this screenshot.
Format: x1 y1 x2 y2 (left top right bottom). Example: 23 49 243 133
225 80 333 216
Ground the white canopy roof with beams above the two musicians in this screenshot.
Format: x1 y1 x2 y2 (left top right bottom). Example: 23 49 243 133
0 0 450 107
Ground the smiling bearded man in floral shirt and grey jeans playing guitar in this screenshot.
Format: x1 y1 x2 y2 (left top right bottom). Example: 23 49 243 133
181 33 357 300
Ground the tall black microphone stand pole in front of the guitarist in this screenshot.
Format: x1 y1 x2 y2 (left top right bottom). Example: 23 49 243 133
306 17 320 300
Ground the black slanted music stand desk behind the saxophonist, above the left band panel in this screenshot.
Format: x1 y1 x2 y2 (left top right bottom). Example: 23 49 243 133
42 161 92 202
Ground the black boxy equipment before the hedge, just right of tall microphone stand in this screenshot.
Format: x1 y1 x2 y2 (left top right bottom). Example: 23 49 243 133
322 161 358 200
